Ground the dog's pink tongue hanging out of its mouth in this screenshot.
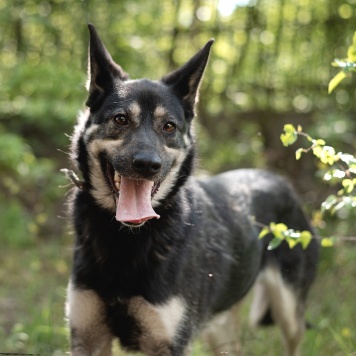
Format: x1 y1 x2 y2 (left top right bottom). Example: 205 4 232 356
116 176 159 224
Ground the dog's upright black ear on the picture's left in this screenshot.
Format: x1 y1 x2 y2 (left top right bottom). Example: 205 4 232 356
86 24 129 108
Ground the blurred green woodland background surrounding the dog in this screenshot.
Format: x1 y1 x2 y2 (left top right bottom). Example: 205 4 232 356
0 0 356 355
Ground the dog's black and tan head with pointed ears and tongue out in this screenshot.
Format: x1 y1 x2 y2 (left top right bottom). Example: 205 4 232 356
72 25 213 226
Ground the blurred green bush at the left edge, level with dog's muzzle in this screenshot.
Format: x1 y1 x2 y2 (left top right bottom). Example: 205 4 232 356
0 126 65 247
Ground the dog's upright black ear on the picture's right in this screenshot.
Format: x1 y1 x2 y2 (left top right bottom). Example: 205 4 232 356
161 39 214 116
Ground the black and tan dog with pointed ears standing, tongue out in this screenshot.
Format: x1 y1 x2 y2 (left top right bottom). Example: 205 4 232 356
66 24 318 356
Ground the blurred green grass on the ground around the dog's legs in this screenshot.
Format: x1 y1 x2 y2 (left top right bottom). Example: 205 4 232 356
0 234 356 356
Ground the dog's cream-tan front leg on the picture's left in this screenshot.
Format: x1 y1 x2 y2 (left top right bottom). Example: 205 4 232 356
66 282 113 356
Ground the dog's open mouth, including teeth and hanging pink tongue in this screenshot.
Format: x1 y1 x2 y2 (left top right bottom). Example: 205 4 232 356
106 163 160 226
